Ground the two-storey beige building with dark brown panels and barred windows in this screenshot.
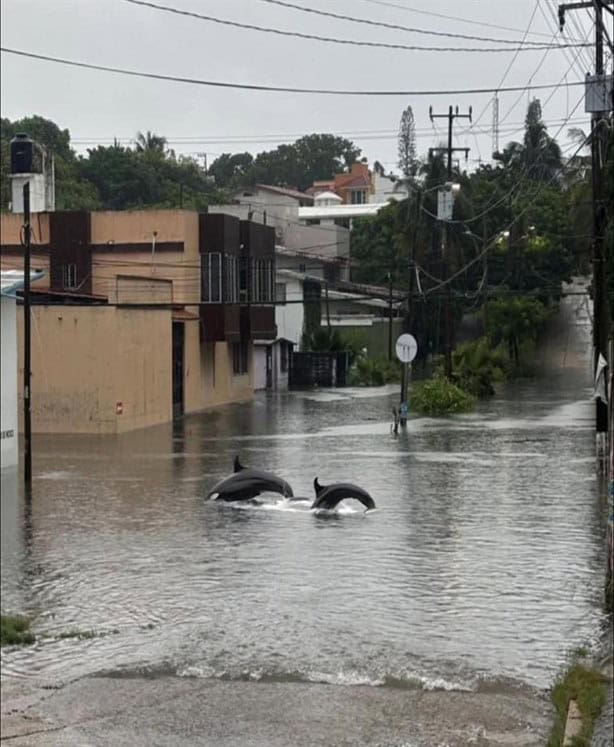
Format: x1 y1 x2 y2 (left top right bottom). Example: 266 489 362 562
0 210 276 433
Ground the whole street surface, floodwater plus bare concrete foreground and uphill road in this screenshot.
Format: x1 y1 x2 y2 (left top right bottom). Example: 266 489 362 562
1 284 605 747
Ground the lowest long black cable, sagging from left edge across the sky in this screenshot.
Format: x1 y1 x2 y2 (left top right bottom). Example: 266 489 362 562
0 47 584 96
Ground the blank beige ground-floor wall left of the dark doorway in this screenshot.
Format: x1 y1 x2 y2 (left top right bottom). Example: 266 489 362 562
18 306 172 433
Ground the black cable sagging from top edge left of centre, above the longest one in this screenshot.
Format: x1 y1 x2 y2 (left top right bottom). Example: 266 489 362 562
123 0 592 52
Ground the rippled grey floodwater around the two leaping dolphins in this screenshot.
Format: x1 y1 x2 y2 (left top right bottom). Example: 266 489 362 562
2 376 603 687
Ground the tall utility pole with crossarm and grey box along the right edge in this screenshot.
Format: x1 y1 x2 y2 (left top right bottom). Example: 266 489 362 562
559 0 614 433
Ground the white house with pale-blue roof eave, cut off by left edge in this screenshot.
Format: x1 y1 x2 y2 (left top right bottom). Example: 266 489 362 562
0 270 43 469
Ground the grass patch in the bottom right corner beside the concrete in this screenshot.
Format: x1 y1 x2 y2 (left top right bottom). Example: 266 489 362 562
547 662 606 747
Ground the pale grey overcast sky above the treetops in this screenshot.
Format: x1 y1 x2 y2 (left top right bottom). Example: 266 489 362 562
1 0 593 169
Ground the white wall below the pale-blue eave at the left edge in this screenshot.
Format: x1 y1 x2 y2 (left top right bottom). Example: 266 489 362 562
0 296 19 468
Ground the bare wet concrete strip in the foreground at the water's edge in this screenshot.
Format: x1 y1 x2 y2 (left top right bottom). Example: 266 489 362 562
2 677 552 747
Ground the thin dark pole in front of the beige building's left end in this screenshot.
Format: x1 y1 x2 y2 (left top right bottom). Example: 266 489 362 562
23 182 32 489
